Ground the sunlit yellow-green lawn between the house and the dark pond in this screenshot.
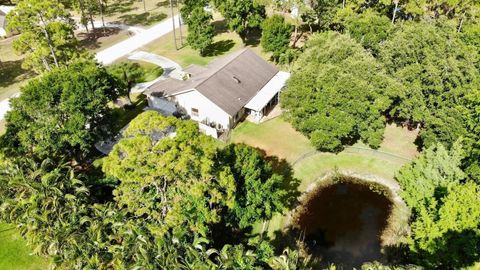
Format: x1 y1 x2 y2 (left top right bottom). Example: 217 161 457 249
230 117 418 236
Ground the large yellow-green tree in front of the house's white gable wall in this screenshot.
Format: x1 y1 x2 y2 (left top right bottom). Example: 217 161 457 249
103 112 234 236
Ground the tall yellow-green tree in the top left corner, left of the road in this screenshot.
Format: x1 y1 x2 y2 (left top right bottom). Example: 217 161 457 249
7 0 78 73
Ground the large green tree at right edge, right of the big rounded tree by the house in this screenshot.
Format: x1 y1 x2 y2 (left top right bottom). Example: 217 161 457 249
380 23 479 147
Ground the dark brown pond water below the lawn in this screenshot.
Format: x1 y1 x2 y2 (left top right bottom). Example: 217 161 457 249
296 179 392 269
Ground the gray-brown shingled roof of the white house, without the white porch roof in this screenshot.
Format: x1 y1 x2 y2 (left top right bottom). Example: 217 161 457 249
145 49 278 116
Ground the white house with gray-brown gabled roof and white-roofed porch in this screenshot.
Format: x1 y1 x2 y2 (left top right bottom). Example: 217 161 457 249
144 49 290 135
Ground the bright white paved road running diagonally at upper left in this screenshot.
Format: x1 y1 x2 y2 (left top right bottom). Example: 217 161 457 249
0 15 179 120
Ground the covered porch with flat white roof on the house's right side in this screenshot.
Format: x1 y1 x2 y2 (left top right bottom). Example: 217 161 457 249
245 71 290 123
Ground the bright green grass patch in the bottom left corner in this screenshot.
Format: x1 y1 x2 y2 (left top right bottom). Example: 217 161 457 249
0 223 49 270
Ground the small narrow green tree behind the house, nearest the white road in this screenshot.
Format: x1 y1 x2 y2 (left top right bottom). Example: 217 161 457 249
187 7 215 56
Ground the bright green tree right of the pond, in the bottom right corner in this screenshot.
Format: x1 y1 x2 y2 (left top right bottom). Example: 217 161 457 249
396 142 480 268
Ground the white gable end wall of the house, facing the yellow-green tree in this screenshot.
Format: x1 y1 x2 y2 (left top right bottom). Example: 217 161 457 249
174 90 231 129
